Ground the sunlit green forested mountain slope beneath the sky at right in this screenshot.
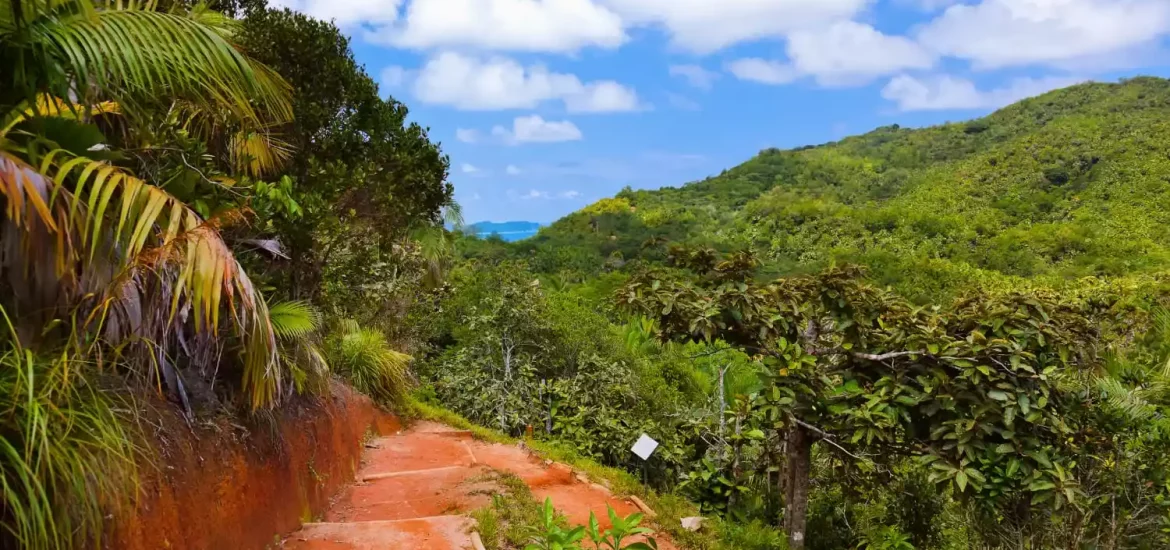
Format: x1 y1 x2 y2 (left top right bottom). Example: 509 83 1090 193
491 77 1170 300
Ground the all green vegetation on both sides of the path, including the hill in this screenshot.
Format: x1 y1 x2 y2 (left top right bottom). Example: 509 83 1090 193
0 0 1170 550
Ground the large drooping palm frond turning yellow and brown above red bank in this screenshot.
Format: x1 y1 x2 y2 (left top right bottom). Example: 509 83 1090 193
0 150 283 407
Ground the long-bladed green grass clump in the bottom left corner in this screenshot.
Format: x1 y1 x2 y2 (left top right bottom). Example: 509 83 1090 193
0 343 137 550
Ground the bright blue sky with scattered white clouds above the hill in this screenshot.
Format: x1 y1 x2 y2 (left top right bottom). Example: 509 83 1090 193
270 0 1170 222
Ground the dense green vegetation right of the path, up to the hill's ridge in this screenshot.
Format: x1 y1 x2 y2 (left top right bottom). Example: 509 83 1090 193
437 78 1170 549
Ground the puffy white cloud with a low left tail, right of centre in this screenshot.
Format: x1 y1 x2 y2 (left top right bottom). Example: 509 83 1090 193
728 21 935 85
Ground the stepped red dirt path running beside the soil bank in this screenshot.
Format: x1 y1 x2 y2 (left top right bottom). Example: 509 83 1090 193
284 422 675 550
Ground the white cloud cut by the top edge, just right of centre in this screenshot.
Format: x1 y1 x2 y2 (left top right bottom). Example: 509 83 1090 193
600 0 870 53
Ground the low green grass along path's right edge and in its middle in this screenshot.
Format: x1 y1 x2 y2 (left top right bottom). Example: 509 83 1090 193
404 399 787 550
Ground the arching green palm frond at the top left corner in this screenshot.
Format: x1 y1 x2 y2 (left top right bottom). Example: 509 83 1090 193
8 0 291 121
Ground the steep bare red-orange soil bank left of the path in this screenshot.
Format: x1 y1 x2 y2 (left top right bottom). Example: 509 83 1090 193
105 384 400 550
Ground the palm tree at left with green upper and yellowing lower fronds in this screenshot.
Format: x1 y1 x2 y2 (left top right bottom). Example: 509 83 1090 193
0 0 297 407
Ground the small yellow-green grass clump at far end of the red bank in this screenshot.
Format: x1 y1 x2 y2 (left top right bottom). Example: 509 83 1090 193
325 319 411 407
